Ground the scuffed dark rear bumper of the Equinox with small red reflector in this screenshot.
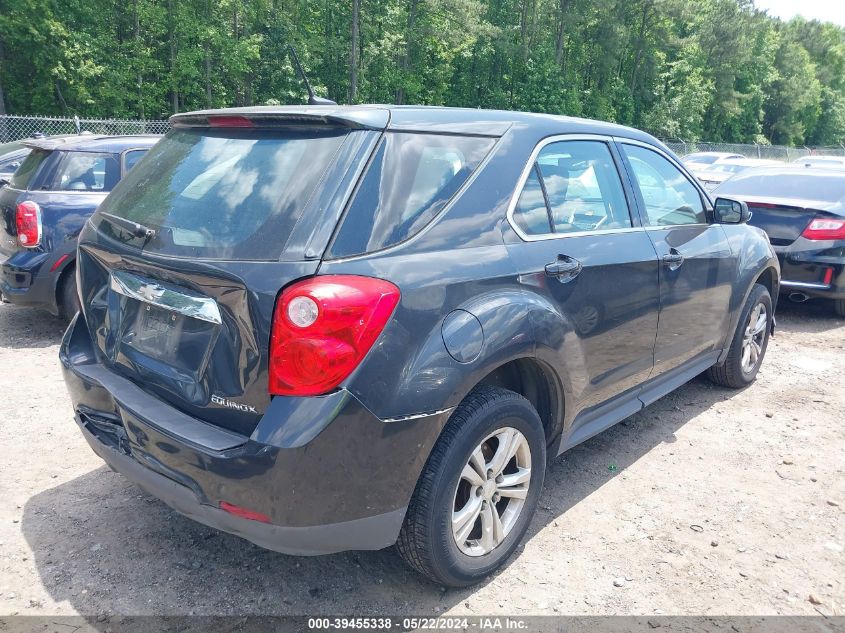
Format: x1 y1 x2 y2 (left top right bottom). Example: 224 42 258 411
60 315 448 555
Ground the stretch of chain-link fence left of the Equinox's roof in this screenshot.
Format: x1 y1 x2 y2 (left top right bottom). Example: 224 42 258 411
0 115 170 143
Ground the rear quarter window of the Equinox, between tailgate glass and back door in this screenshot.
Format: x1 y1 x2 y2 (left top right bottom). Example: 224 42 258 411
331 132 495 257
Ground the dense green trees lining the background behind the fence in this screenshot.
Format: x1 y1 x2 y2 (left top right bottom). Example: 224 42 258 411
0 0 845 145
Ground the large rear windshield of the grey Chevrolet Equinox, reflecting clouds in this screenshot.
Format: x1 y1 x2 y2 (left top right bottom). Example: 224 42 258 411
99 129 346 260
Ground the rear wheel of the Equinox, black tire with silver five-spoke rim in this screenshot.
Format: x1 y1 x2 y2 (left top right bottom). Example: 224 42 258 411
397 386 546 587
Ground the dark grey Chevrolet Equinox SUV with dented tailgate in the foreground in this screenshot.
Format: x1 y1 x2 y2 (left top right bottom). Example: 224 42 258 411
60 106 780 586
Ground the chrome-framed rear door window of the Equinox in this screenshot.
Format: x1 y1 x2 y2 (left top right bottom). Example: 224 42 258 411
513 141 632 235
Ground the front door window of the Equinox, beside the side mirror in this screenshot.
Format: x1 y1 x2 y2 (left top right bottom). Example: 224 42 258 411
623 144 707 226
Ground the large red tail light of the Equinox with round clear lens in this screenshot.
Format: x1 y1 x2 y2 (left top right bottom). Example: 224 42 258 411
269 275 400 396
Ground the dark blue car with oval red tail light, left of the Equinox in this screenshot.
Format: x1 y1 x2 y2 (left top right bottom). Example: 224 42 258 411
0 134 160 319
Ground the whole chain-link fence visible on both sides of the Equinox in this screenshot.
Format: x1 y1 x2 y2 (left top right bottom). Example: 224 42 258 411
0 115 845 162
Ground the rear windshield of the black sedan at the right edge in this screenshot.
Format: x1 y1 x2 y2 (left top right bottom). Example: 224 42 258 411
716 170 845 204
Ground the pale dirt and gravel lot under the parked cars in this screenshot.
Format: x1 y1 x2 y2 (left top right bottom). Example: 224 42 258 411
0 305 845 621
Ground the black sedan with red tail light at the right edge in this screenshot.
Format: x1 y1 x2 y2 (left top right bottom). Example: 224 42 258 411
715 165 845 316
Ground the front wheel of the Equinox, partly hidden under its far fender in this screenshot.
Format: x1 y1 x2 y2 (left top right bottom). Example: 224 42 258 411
707 284 773 389
